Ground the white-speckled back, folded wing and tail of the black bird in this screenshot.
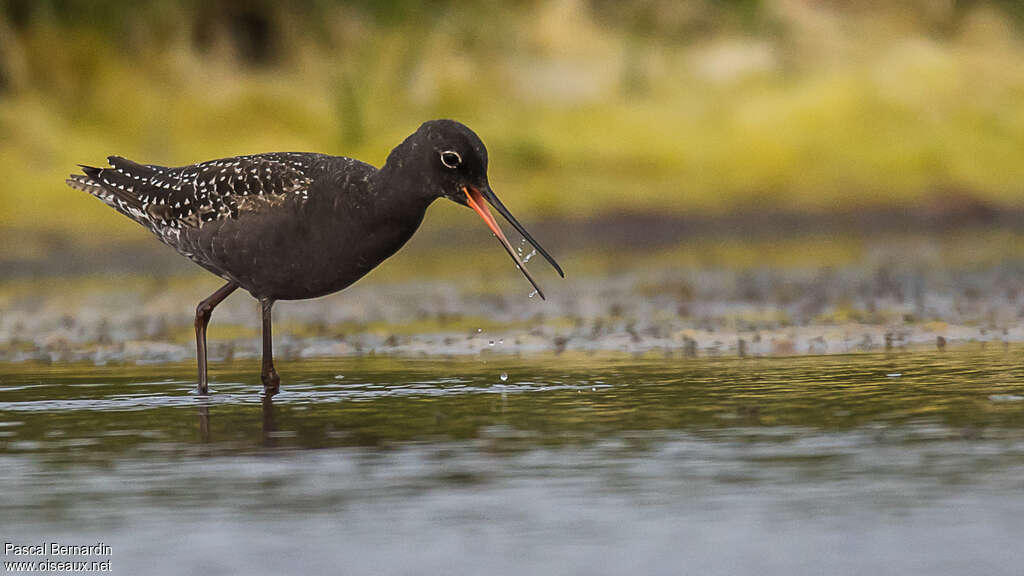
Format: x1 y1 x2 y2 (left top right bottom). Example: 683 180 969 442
67 153 387 292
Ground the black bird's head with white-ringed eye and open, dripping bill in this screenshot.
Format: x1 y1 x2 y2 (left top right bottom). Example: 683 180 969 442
388 120 565 298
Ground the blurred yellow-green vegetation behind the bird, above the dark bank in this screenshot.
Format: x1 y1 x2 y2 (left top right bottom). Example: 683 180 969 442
0 0 1024 245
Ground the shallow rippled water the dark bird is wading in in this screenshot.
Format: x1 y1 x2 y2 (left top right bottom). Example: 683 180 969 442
0 347 1024 575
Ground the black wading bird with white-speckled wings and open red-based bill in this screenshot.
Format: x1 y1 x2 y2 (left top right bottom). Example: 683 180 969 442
66 119 565 398
